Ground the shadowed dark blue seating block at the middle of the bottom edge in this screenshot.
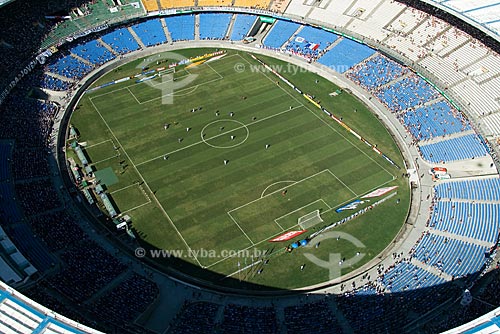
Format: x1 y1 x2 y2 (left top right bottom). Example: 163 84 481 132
221 304 278 334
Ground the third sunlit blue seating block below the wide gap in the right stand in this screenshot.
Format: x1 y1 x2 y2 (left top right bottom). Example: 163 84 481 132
415 233 488 277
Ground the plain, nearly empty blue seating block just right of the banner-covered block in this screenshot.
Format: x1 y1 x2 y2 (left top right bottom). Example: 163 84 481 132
318 38 375 73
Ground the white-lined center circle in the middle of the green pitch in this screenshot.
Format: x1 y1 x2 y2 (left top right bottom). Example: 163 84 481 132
200 119 250 148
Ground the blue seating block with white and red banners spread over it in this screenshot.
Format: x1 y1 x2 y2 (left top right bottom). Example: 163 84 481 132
286 26 338 58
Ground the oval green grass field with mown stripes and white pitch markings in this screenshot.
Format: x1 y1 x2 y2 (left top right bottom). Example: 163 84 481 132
68 49 410 289
